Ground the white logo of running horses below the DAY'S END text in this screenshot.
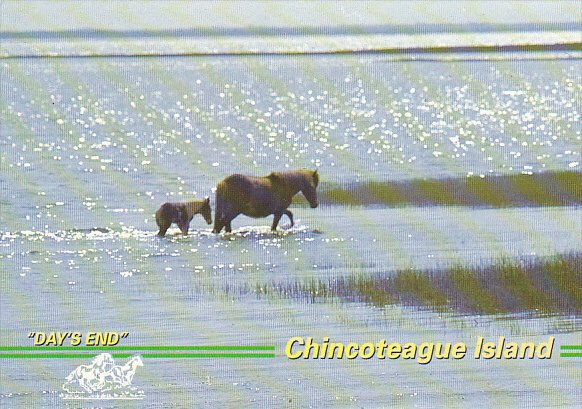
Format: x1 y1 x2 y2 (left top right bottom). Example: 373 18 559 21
63 353 143 399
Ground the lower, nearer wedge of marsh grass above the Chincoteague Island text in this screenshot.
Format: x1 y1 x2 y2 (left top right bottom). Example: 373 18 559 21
255 253 582 315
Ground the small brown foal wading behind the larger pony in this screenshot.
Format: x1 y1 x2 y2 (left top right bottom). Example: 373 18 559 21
156 198 212 237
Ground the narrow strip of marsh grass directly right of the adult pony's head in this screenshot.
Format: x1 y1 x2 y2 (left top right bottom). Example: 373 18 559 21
319 172 582 207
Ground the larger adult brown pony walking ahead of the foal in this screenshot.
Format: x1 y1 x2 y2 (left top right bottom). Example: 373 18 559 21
212 169 319 233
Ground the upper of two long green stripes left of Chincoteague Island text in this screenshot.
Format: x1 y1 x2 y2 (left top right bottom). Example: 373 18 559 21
0 345 275 351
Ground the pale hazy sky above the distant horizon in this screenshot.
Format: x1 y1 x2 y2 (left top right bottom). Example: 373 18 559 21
0 0 582 31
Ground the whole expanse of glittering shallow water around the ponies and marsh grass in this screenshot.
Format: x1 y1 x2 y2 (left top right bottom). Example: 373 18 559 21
0 52 582 408
